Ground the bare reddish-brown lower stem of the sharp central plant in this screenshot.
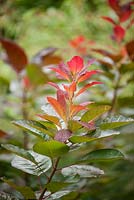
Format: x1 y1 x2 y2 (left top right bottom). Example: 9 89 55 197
39 158 60 200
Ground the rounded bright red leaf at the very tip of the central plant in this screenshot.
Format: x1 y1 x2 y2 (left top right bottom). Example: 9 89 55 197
67 56 84 75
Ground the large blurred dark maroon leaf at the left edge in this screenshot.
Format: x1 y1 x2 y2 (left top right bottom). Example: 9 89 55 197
0 39 28 73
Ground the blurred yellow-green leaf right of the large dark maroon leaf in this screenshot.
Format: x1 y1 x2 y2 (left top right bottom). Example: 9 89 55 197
26 64 49 86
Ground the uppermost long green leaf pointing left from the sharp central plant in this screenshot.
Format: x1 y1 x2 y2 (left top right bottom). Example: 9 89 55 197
13 120 54 139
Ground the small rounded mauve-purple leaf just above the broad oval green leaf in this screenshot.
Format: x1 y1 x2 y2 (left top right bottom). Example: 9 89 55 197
54 129 72 142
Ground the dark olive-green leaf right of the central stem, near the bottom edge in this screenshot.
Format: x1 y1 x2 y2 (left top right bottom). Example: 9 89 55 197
46 181 70 193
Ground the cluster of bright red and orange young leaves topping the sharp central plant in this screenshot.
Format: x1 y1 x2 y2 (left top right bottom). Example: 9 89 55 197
47 56 101 122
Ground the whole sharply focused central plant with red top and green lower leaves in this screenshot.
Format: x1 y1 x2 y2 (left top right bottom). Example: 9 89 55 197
2 56 133 200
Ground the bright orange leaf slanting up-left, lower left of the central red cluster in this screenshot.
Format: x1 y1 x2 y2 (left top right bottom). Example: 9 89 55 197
47 97 65 120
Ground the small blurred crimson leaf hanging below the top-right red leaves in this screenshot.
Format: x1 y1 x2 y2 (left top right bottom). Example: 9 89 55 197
114 25 125 42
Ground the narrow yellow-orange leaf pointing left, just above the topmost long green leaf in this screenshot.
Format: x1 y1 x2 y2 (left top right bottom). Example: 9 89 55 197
37 114 61 127
